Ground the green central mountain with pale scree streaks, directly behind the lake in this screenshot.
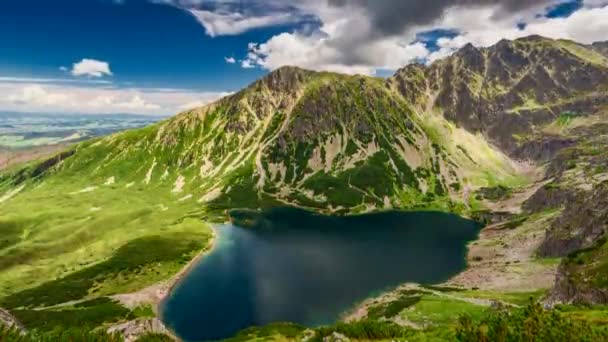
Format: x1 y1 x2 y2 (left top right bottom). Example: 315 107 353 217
0 67 516 212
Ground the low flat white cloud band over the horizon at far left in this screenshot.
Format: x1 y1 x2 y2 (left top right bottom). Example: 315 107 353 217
0 80 228 115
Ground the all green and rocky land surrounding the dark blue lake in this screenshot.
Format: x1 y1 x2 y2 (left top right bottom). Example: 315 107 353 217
0 36 608 341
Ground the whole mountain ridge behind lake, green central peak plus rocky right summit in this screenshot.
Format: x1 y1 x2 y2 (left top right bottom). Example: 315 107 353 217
5 36 608 212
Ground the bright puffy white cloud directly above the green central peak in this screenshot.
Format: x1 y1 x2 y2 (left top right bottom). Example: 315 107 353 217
242 2 429 74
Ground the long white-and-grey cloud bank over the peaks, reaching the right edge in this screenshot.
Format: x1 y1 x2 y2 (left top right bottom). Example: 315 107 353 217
235 0 608 74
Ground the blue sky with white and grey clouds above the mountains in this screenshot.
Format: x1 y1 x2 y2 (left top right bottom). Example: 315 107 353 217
0 0 608 115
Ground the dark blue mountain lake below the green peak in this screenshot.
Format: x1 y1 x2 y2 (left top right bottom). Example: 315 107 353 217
161 208 480 341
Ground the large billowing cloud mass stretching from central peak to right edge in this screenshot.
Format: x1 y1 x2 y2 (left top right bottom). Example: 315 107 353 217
223 0 608 74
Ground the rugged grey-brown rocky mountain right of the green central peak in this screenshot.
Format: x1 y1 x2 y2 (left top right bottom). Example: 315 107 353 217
391 36 608 156
